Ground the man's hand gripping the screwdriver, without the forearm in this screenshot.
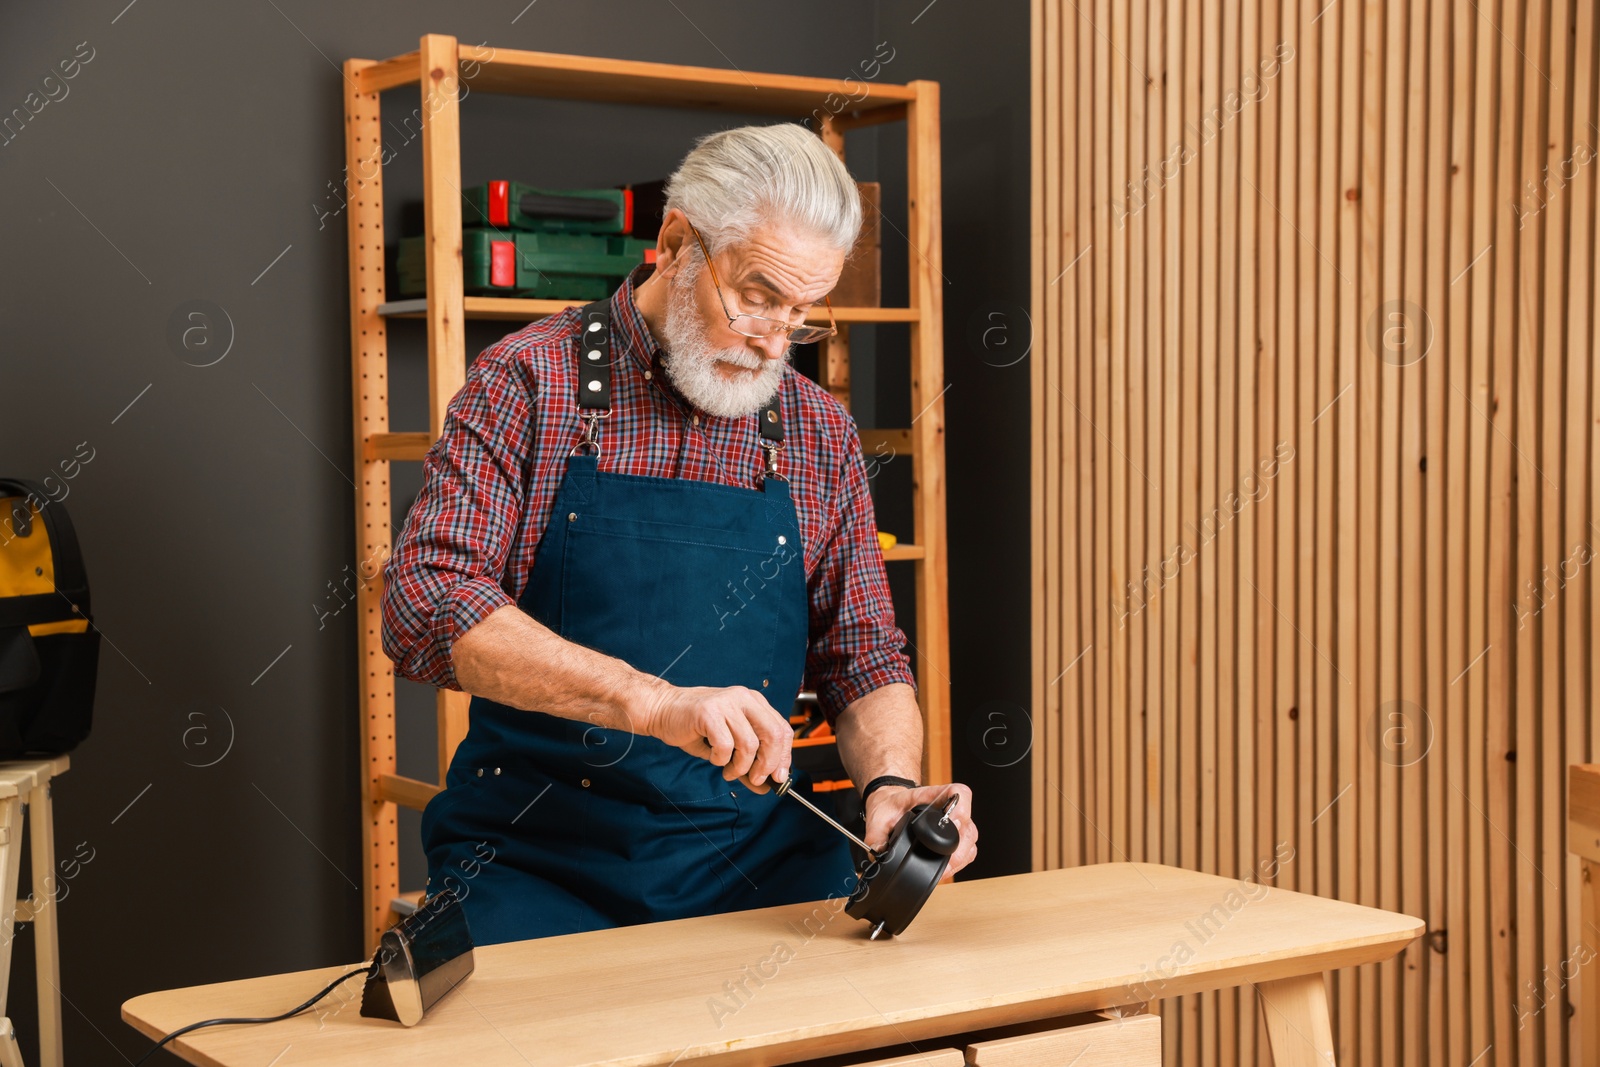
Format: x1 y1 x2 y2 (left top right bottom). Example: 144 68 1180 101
638 683 794 792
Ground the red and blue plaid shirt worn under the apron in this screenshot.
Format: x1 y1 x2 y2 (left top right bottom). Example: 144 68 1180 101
382 264 915 721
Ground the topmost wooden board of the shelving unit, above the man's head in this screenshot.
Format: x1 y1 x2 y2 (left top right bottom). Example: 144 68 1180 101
355 45 917 125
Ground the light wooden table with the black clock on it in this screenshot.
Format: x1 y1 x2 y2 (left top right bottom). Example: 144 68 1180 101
122 864 1422 1067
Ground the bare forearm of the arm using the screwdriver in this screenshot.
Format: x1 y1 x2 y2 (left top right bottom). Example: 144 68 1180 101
450 605 667 733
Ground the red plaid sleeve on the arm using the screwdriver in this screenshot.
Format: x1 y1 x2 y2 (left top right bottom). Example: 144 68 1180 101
382 346 536 689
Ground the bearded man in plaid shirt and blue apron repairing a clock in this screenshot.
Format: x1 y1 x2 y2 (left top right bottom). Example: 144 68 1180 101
382 125 978 944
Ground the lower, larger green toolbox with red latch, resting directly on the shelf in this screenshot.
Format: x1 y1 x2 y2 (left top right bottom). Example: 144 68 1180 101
395 229 656 301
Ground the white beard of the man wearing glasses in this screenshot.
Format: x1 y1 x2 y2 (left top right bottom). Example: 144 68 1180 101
661 261 790 419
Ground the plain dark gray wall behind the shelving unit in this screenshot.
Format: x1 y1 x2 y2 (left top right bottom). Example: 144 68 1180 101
0 0 1029 1064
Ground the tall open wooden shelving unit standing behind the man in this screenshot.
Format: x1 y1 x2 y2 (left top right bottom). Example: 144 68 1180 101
344 34 950 952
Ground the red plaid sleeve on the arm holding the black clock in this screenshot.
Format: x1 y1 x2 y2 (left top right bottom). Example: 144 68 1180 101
806 422 917 723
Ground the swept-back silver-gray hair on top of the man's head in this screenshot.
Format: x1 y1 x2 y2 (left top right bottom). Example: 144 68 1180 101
666 123 861 258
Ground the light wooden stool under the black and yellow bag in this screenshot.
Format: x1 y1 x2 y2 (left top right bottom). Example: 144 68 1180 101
0 755 70 1067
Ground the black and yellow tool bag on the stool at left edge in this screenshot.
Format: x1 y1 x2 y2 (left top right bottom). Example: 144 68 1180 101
0 478 99 760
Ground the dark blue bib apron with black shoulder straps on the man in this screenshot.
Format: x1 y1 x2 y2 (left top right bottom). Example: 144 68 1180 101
422 304 854 945
